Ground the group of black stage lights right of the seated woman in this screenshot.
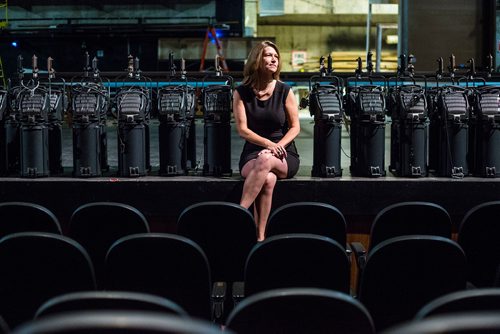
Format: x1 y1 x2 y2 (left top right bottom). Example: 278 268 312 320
300 53 500 178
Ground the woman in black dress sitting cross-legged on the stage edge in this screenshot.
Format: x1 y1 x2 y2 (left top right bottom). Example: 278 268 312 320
233 41 300 241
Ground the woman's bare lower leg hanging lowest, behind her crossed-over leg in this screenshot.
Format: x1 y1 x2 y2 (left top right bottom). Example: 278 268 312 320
254 172 278 241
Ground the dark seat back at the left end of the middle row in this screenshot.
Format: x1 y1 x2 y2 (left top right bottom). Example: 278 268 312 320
0 232 96 328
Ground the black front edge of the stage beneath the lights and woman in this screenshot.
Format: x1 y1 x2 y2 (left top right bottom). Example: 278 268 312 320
0 173 500 235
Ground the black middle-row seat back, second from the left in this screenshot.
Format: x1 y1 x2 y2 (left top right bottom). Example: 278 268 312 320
105 233 211 319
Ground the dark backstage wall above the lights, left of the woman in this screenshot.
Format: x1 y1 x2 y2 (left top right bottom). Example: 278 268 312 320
0 0 244 75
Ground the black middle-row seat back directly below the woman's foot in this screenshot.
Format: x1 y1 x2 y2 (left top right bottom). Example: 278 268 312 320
245 233 350 296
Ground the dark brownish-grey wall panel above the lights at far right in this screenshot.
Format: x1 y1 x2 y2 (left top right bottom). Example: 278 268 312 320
408 0 496 71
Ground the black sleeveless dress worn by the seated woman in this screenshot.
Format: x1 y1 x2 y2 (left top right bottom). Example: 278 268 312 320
236 81 300 178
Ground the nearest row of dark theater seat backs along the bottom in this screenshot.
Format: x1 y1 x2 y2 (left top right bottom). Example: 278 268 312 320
3 288 500 334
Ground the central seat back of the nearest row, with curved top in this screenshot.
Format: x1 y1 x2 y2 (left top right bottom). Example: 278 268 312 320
226 288 375 334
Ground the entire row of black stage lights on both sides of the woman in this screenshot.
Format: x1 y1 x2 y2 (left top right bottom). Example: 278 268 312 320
0 53 500 177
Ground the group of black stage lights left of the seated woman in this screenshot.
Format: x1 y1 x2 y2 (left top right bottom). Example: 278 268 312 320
0 54 233 177
